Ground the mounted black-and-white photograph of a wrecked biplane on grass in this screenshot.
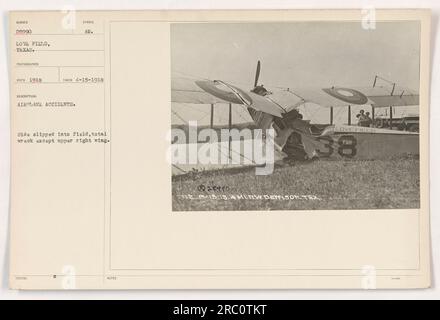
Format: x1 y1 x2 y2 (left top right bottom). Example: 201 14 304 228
170 21 420 211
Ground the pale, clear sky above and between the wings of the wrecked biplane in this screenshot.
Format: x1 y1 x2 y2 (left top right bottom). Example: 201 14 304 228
171 21 420 123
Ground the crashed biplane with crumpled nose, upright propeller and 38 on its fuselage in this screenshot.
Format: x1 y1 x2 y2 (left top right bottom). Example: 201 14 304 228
171 61 419 174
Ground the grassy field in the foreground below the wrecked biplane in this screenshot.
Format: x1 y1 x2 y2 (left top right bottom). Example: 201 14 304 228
172 157 420 211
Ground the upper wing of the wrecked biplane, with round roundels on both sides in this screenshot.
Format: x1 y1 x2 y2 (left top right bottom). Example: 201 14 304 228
171 78 419 117
